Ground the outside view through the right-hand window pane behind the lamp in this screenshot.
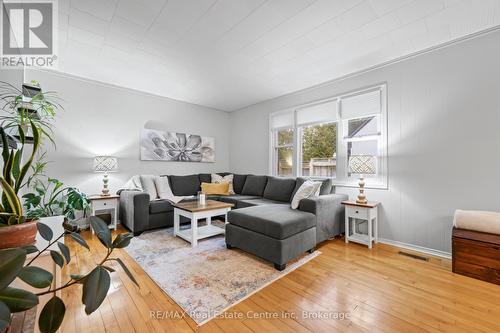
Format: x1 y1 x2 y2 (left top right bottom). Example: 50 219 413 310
346 116 381 178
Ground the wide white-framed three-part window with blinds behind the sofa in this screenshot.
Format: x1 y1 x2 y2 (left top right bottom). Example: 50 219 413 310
270 85 387 188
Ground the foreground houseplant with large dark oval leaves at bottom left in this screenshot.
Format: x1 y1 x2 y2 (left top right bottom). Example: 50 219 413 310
0 216 137 333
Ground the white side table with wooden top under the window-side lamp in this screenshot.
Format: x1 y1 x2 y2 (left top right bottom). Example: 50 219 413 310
342 201 379 249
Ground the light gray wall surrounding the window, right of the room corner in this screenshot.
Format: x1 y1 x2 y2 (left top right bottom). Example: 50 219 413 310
230 32 500 252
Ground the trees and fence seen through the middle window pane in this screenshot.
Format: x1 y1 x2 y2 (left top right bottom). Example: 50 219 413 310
301 123 337 178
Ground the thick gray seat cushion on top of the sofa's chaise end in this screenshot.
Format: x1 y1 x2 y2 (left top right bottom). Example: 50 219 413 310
227 205 316 239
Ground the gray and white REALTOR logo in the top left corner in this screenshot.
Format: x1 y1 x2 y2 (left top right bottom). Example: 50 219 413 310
1 0 56 67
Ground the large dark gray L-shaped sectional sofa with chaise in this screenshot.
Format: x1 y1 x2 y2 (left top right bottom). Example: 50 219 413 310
119 173 348 270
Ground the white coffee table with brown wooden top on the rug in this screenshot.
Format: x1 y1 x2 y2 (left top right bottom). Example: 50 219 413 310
172 200 234 247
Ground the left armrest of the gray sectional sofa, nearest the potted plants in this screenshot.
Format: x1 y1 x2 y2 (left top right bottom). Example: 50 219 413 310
120 191 149 234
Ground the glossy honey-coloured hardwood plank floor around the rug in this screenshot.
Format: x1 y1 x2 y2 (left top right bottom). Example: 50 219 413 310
61 227 500 333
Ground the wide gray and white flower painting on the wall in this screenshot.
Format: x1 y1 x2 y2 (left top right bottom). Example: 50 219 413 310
141 128 215 162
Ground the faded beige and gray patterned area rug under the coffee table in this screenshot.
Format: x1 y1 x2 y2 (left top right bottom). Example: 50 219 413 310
126 221 320 325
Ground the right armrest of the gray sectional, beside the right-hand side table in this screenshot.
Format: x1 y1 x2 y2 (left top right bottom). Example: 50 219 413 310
299 194 349 243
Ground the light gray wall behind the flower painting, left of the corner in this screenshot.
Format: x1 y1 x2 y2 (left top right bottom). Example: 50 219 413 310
26 70 229 194
